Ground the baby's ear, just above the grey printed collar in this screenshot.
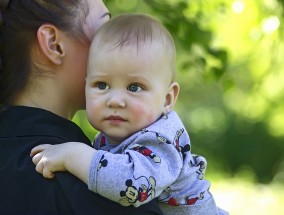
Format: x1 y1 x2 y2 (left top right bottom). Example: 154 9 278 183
164 82 179 114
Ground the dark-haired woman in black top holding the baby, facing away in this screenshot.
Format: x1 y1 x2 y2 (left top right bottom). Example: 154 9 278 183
0 0 160 215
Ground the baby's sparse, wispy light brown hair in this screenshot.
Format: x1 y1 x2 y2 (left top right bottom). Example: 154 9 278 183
90 14 176 81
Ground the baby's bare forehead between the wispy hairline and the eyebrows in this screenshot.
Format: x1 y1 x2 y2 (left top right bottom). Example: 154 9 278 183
90 44 175 82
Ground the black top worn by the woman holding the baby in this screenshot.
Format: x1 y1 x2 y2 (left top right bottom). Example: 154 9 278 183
0 106 161 215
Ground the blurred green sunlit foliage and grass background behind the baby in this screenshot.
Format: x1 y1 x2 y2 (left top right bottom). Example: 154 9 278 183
74 0 284 214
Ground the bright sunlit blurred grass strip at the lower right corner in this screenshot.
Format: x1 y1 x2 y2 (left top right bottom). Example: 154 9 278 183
211 178 284 215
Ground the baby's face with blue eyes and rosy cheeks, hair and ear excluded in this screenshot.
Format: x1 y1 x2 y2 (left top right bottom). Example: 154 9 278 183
86 43 172 143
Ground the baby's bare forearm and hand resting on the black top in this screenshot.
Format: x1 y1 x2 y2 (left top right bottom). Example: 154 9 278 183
31 142 96 184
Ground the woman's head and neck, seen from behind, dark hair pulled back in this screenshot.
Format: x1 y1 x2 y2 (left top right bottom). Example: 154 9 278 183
0 0 109 116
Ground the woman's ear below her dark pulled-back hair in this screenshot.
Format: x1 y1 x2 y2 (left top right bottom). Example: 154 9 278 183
37 24 65 65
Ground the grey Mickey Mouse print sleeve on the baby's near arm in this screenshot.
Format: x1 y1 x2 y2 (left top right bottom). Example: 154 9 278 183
88 132 182 207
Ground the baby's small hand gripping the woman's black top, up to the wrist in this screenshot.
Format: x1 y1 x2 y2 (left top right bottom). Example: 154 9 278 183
30 144 68 178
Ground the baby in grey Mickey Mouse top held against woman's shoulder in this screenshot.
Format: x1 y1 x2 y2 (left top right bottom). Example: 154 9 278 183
31 14 227 215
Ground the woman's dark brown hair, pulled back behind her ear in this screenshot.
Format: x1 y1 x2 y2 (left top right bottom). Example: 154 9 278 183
0 0 87 109
